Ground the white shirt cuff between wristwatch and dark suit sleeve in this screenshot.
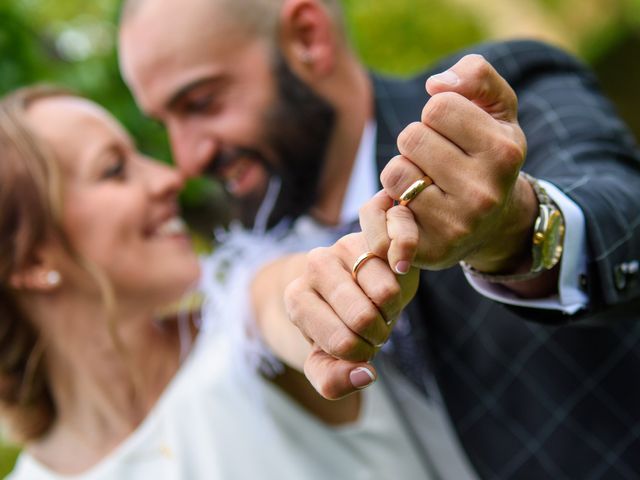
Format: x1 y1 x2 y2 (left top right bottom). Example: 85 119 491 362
465 180 589 315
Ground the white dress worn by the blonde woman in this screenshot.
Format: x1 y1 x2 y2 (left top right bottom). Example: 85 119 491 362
9 222 436 480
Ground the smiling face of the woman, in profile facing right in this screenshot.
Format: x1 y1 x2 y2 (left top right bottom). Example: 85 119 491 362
27 97 199 305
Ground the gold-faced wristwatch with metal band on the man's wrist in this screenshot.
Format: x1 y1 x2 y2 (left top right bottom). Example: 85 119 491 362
460 172 565 283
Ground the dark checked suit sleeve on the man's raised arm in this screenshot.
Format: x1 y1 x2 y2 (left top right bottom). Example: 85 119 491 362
448 41 640 323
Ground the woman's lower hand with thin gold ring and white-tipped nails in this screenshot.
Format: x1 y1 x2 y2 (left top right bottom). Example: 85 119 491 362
285 234 418 399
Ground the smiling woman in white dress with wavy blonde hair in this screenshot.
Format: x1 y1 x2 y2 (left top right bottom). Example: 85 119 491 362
0 89 436 480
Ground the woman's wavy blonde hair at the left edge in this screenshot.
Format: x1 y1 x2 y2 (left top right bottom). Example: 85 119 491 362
0 85 124 442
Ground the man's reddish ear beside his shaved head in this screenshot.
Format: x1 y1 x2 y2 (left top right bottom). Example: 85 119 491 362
279 0 339 80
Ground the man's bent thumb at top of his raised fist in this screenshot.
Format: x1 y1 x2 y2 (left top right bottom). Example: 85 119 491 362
426 54 518 123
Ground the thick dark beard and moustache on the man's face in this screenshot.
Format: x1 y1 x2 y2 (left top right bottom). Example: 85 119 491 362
209 53 336 228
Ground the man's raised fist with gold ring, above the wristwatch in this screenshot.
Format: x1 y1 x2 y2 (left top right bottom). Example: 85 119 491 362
360 55 537 272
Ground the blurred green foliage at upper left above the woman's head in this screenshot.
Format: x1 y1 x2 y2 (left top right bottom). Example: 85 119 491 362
0 0 168 159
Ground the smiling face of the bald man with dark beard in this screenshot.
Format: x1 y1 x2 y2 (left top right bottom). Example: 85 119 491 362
120 0 334 223
